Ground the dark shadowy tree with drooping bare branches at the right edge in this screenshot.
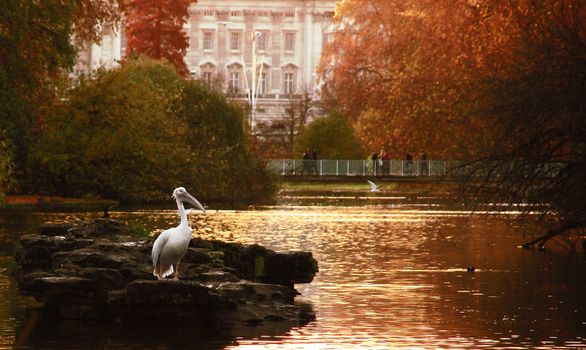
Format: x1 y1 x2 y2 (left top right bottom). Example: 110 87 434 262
456 0 586 246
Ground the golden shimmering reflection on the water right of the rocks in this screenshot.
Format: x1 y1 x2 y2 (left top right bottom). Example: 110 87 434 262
181 206 583 349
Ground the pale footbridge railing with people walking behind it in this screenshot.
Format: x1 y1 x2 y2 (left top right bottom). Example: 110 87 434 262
267 159 458 176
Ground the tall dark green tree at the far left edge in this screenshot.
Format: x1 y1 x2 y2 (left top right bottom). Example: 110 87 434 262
0 0 76 176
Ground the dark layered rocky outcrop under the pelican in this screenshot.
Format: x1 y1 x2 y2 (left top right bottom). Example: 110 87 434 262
16 219 317 327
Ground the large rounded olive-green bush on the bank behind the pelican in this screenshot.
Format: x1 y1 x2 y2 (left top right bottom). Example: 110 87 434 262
33 60 186 201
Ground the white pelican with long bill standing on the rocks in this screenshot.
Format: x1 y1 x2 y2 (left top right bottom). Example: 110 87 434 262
151 187 205 280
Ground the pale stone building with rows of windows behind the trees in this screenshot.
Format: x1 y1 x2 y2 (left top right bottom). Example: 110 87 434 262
75 0 337 130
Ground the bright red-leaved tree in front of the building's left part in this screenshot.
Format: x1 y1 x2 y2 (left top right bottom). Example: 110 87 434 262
126 0 195 75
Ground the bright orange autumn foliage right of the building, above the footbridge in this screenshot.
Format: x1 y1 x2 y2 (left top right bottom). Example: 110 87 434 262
318 0 584 159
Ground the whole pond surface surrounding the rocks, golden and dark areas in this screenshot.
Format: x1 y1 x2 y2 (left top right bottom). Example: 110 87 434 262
0 204 586 349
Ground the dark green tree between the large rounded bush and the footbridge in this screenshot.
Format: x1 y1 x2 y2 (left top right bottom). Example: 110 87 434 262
179 81 275 203
